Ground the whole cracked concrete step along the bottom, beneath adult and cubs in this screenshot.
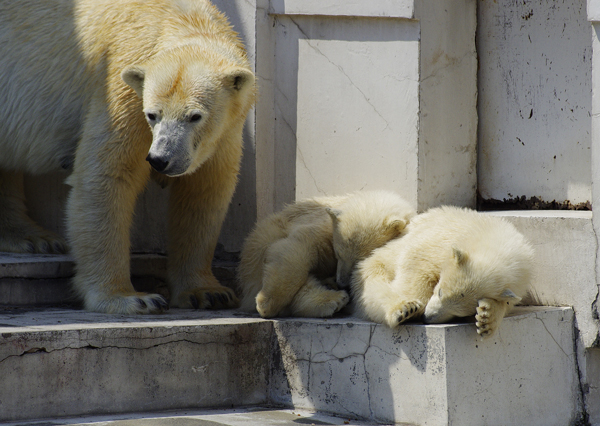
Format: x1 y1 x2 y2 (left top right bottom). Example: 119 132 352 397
0 307 581 425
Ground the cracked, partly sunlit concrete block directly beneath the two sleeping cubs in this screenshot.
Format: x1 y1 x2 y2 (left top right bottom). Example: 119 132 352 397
270 308 582 425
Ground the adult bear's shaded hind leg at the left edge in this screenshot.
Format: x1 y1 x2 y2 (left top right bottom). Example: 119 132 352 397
0 170 68 253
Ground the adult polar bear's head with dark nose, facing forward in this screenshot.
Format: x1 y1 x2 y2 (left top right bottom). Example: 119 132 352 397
121 47 255 176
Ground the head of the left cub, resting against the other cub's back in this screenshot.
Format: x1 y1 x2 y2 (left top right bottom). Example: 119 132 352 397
327 191 415 287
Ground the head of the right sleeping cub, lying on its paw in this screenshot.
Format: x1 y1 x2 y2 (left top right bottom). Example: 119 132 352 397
423 248 521 324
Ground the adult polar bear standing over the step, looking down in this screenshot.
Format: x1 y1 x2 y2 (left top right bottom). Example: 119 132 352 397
0 0 255 313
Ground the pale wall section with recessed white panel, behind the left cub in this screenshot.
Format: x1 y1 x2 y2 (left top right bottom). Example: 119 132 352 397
257 0 477 213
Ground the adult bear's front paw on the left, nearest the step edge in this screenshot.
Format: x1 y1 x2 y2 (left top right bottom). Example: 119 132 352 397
84 292 169 315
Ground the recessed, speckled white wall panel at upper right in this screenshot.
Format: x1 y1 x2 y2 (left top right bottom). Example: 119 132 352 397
477 0 592 203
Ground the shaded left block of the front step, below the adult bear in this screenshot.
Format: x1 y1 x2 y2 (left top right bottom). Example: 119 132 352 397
0 310 272 421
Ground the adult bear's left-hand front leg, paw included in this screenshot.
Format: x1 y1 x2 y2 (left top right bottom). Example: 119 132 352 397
67 106 167 314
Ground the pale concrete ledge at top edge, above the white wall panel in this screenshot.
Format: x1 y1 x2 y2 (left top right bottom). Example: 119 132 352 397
270 0 414 19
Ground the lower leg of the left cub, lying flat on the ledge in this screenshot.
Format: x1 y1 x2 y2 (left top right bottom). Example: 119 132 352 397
289 276 350 318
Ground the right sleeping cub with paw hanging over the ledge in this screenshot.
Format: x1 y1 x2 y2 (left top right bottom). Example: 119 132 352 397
351 207 533 336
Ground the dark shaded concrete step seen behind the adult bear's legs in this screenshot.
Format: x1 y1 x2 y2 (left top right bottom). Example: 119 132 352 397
0 252 237 306
